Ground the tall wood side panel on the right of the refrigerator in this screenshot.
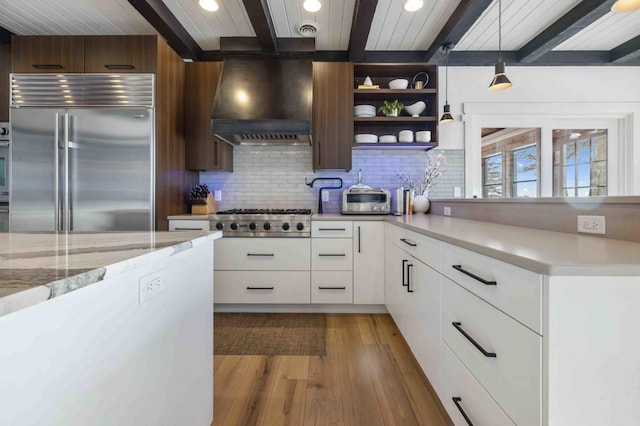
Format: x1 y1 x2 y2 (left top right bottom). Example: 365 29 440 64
155 39 199 231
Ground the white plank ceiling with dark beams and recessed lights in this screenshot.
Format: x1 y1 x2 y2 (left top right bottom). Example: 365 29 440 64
0 0 640 66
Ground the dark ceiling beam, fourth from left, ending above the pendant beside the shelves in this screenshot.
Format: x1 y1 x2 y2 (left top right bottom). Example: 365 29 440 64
424 0 492 64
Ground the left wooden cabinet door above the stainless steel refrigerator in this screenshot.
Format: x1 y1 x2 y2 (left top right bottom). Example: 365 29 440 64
11 36 84 73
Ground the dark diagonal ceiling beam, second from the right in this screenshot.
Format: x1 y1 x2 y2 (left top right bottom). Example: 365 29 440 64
517 0 611 63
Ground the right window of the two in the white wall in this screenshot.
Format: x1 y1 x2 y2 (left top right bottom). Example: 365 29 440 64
553 129 607 197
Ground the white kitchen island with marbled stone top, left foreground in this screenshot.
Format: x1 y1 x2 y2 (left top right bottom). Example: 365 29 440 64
0 232 221 426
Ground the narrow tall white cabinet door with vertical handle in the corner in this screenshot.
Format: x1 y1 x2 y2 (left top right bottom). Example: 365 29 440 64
353 221 385 305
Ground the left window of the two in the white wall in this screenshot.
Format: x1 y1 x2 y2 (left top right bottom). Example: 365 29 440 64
482 128 540 198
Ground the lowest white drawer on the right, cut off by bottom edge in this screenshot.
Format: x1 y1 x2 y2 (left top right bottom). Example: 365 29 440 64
440 342 514 426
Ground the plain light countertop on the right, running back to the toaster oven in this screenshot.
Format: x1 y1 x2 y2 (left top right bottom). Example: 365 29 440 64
312 214 640 276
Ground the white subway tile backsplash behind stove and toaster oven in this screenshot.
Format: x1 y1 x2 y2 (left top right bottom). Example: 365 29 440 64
200 146 464 213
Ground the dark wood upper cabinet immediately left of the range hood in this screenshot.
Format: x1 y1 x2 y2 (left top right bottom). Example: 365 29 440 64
185 62 233 172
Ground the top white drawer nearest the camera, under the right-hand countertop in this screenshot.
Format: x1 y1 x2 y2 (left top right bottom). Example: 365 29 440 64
441 243 542 334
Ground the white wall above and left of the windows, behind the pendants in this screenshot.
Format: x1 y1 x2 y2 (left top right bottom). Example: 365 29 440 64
439 64 640 149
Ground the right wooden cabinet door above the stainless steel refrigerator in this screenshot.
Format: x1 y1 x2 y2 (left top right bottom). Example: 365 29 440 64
84 36 157 73
